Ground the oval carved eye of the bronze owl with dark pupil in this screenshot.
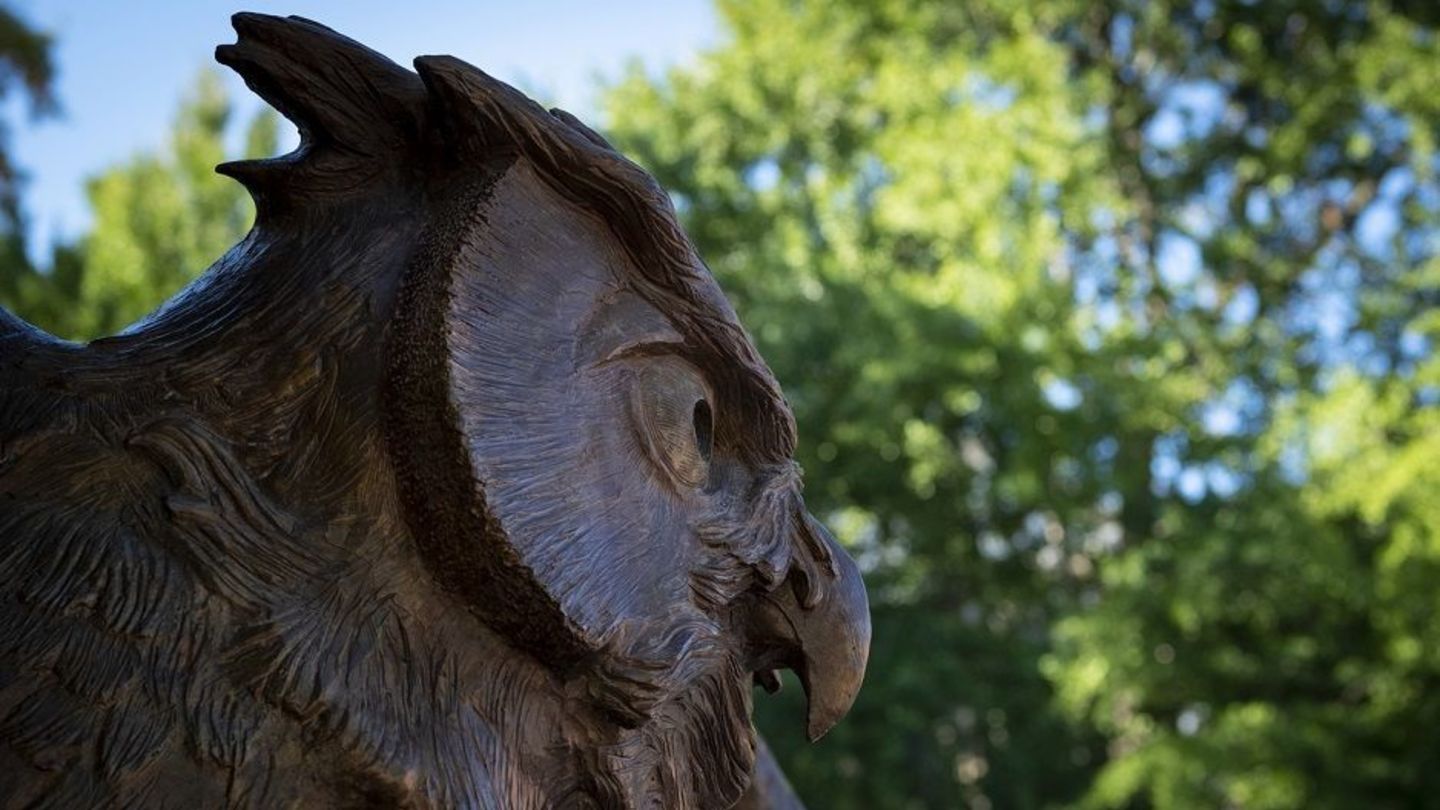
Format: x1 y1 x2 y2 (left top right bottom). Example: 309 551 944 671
632 357 714 489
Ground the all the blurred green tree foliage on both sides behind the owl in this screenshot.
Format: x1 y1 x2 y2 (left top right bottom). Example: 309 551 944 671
0 0 1440 810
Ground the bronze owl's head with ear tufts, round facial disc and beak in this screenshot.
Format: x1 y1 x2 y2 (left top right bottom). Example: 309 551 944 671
217 14 870 804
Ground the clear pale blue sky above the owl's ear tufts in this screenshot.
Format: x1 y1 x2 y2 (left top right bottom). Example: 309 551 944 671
10 0 719 264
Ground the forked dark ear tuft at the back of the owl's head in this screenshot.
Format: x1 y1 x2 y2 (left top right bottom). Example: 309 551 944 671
215 13 425 218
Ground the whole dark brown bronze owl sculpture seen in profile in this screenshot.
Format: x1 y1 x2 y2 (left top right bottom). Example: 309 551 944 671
0 14 870 809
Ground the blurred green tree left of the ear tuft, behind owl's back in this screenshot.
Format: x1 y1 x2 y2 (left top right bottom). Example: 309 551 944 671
7 71 276 339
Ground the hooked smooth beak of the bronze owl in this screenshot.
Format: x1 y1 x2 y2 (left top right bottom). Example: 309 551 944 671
757 516 870 742
